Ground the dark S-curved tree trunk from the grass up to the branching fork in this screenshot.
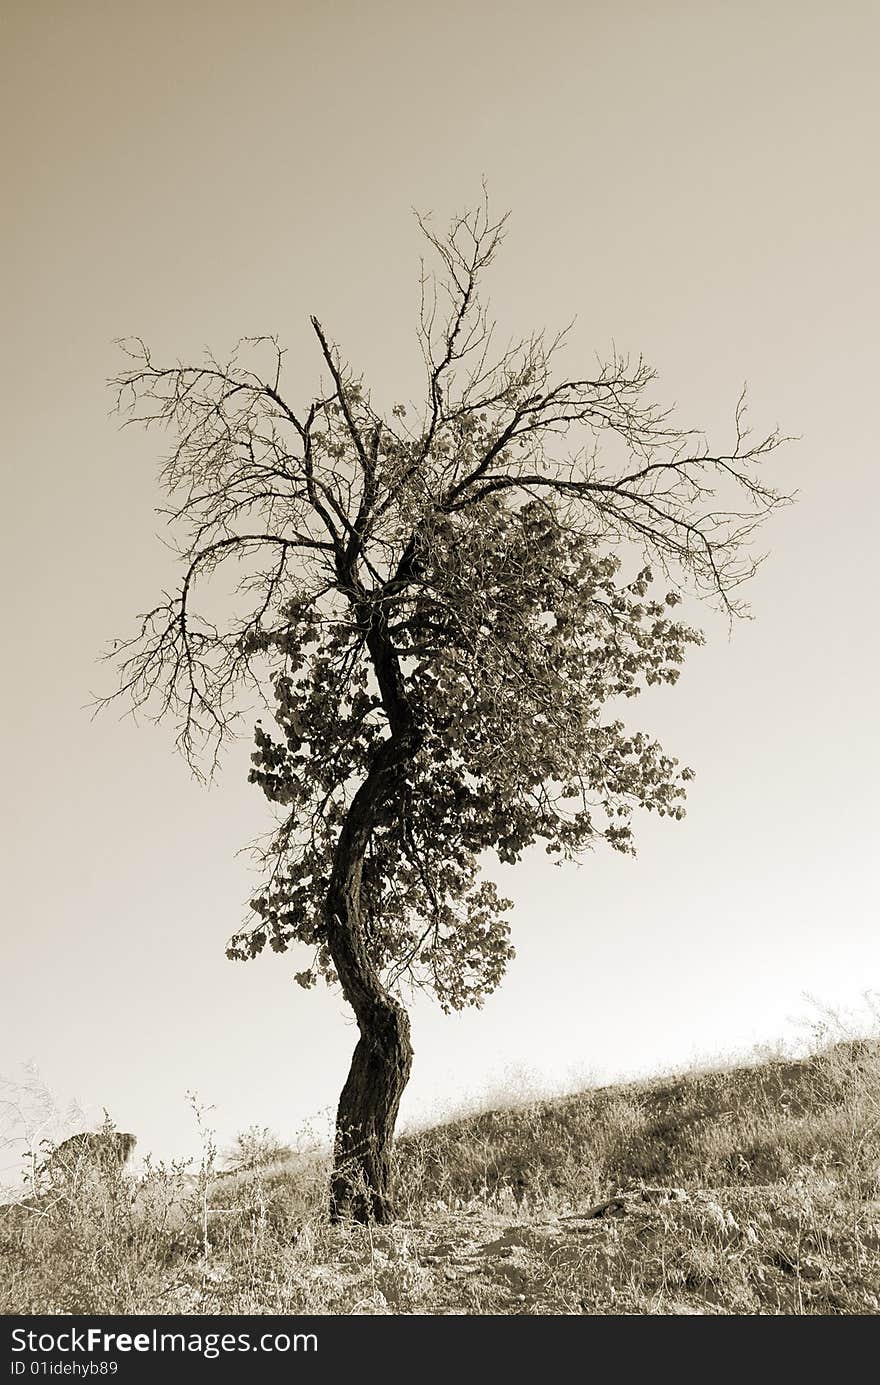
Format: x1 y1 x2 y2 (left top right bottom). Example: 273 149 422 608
327 625 421 1222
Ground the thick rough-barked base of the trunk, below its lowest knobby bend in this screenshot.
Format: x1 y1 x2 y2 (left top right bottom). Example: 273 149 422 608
330 997 413 1223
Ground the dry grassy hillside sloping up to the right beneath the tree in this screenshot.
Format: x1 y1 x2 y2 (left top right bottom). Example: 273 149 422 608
0 1040 880 1314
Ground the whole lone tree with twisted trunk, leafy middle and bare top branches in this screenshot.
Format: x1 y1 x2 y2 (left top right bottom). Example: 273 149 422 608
108 201 786 1222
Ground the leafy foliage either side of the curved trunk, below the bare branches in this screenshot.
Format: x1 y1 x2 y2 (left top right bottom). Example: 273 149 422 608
230 504 700 1008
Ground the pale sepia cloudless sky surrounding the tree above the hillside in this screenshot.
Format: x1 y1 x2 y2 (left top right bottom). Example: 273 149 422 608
0 0 880 1174
